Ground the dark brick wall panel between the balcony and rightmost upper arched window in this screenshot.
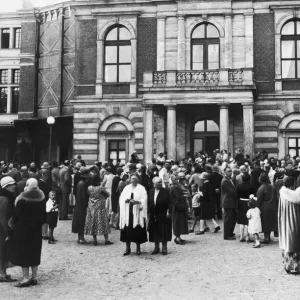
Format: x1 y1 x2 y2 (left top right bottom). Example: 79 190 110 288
253 13 275 92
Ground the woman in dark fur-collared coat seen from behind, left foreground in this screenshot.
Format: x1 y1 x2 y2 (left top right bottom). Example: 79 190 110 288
11 178 46 287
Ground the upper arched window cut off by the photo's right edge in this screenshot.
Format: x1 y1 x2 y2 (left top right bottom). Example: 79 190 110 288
281 20 300 79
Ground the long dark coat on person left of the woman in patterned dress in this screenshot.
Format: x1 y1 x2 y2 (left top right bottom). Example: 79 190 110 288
72 180 89 234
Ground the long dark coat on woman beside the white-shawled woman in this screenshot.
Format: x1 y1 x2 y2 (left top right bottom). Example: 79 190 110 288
148 188 172 243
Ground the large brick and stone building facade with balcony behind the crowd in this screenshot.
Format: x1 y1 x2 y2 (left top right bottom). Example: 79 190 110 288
0 0 300 164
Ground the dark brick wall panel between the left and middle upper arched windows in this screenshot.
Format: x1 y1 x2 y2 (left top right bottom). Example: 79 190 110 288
137 18 157 84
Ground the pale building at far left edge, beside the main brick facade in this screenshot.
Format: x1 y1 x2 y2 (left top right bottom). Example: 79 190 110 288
0 13 21 161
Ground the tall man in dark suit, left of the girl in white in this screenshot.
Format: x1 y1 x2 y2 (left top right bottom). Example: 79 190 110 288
221 167 237 240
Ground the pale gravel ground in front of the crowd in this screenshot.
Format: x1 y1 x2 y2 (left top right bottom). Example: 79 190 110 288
0 221 300 300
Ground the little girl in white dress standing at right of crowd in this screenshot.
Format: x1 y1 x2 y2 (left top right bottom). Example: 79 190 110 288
247 195 262 248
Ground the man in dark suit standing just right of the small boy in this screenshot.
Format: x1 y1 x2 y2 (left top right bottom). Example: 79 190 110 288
59 160 72 220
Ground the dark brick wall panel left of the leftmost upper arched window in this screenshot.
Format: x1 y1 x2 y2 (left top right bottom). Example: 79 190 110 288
75 20 97 95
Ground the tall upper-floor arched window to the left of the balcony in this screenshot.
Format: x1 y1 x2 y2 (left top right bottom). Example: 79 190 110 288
104 25 131 82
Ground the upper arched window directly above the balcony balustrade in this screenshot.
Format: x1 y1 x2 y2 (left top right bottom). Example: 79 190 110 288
191 23 220 70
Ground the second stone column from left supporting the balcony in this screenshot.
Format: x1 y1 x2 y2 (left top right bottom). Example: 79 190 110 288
167 105 177 160
